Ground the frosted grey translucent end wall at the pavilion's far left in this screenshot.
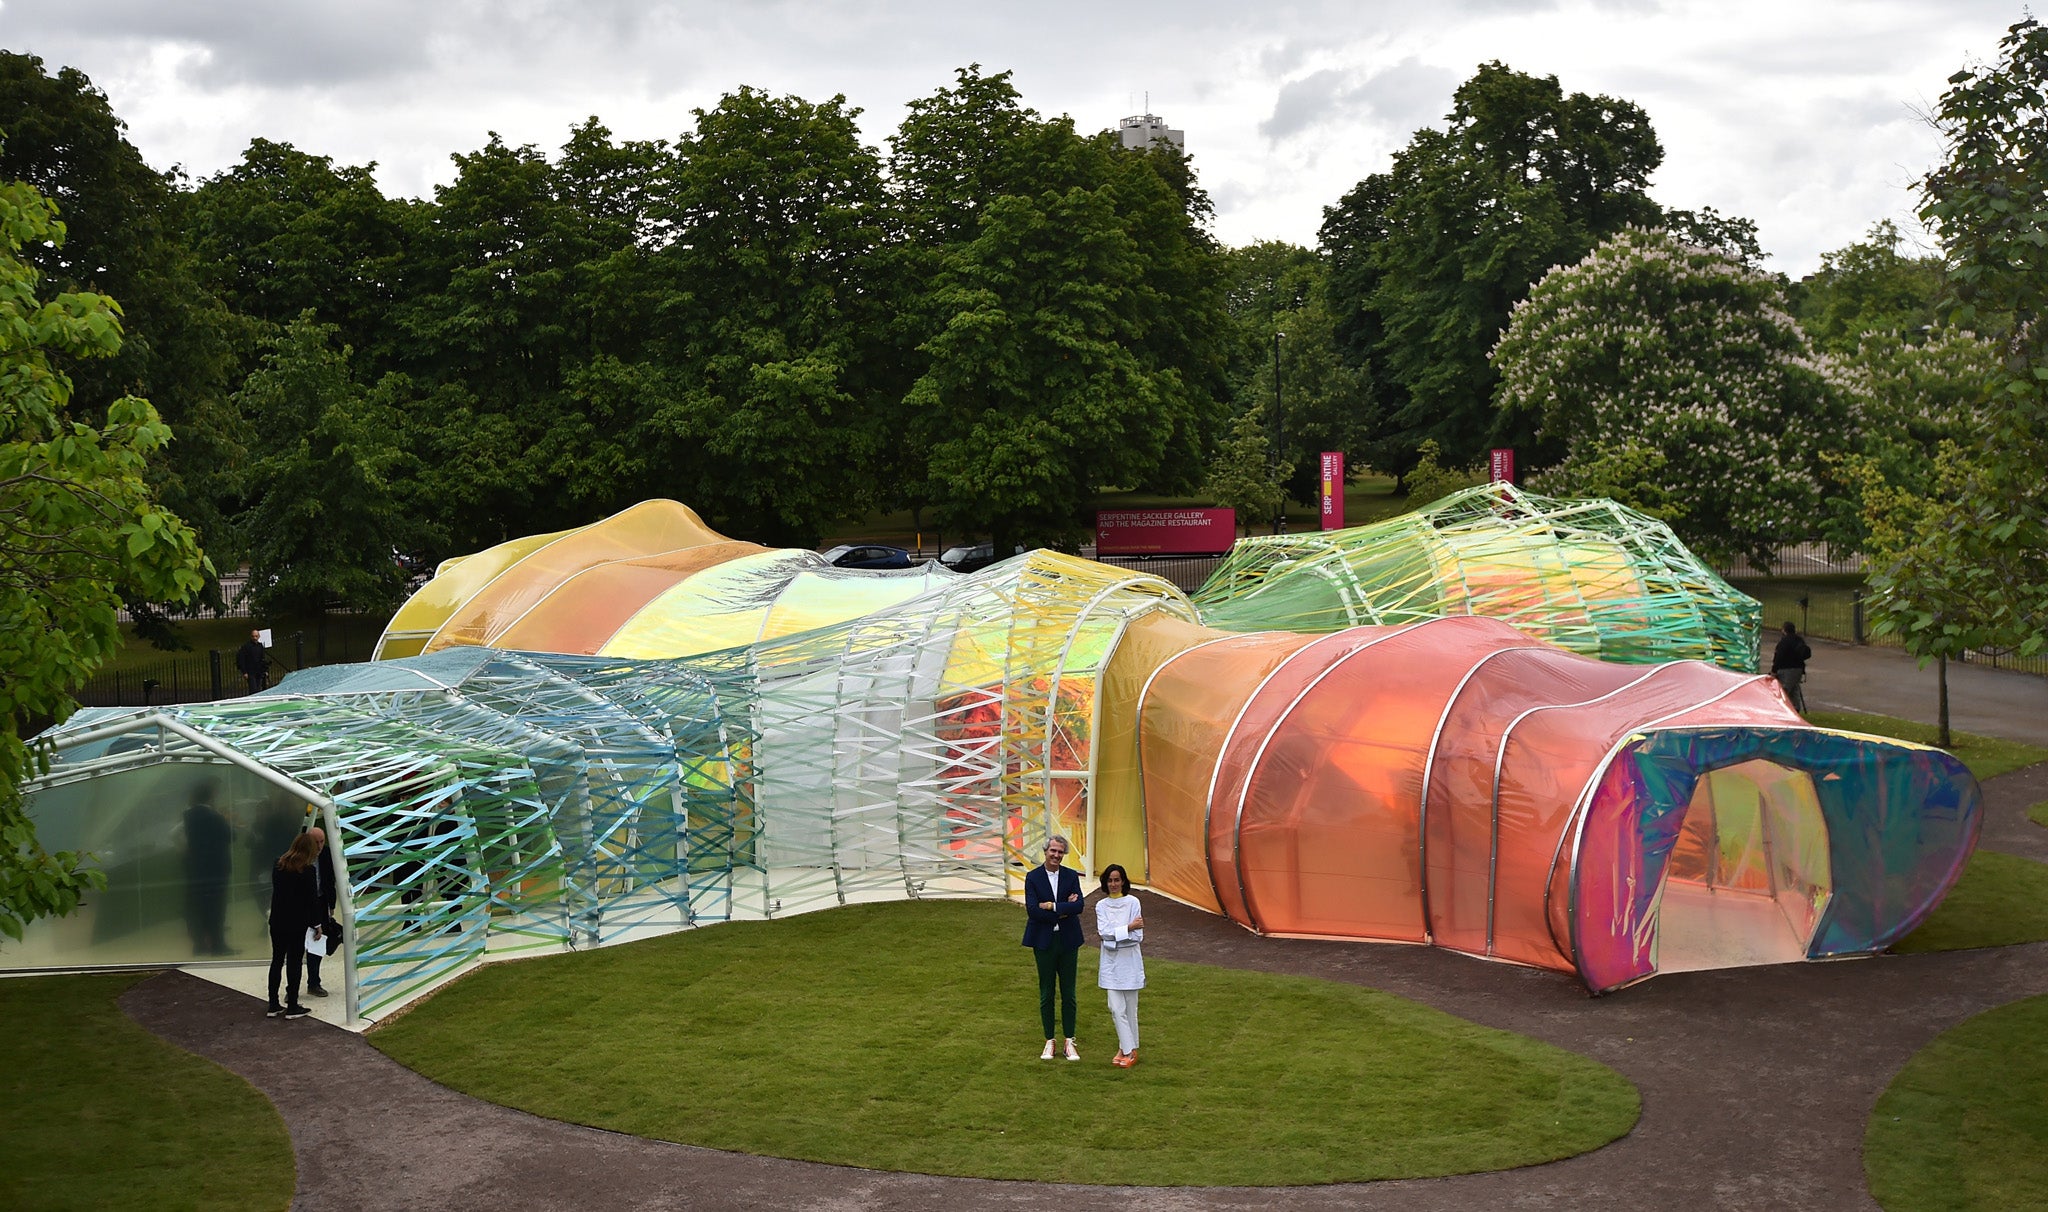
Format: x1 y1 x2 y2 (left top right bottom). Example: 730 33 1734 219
18 762 307 968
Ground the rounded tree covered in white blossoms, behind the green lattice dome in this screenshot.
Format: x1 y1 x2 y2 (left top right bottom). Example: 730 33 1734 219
1491 227 1866 561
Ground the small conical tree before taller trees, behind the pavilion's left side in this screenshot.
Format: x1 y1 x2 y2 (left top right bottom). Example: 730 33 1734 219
236 311 418 618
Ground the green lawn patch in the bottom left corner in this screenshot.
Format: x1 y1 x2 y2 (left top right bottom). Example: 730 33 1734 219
0 975 297 1212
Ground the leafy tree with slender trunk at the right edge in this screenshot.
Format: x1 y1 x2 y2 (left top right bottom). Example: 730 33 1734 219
1851 18 2048 735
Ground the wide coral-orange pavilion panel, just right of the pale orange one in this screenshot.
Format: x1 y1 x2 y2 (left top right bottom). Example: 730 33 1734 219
1239 618 1528 942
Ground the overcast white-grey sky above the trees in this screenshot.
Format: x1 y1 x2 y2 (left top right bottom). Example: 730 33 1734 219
0 0 2023 276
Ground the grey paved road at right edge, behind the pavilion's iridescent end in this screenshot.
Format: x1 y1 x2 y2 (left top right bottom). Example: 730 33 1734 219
1763 635 2048 745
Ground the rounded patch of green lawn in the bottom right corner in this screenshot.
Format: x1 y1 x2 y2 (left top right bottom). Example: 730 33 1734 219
1864 997 2048 1212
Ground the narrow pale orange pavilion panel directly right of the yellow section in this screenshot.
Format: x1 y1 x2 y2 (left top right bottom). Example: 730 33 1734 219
1139 633 1313 913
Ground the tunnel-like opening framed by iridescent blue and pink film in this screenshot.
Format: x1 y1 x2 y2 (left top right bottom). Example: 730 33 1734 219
1655 760 1833 972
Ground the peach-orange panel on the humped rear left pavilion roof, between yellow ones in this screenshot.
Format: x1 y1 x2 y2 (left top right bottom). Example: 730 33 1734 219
426 502 725 653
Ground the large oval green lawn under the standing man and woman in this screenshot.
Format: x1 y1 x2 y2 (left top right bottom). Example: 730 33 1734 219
371 901 1638 1185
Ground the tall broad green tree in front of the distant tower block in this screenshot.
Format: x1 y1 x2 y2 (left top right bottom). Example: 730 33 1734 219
889 68 1233 540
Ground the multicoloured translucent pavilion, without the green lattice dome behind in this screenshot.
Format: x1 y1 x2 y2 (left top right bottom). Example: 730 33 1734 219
0 502 1980 1020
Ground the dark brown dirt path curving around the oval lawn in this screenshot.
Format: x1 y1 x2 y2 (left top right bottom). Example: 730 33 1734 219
123 768 2048 1212
